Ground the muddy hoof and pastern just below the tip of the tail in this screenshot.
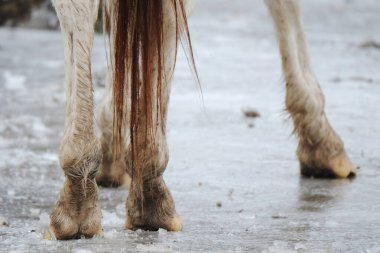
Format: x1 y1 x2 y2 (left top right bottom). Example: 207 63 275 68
125 178 182 231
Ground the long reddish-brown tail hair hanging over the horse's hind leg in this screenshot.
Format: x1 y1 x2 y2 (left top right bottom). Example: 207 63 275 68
105 0 199 200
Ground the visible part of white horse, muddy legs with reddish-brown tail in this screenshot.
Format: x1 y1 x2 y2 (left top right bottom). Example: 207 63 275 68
46 0 355 239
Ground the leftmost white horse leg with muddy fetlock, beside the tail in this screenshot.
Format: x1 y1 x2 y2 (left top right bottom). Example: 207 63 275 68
47 0 102 239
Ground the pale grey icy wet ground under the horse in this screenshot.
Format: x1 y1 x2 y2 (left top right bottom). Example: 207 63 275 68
0 0 380 253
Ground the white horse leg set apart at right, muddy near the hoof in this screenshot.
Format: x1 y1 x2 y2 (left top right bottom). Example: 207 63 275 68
266 0 356 178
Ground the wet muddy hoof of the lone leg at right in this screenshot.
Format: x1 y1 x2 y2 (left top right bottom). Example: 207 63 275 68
297 140 356 178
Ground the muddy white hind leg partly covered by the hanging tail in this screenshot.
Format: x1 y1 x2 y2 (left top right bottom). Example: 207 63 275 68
125 1 182 231
